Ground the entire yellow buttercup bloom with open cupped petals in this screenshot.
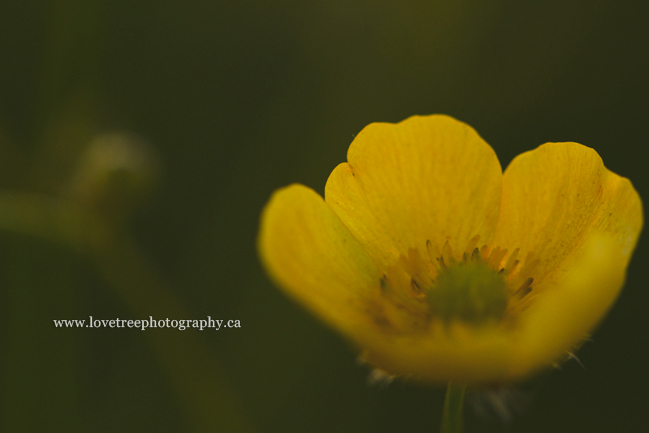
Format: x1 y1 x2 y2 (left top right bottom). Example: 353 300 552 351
258 115 643 384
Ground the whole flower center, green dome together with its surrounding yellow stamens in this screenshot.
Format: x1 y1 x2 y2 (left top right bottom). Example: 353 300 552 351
378 235 540 332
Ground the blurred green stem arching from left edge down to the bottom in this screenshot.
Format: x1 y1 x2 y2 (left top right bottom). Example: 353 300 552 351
0 192 253 432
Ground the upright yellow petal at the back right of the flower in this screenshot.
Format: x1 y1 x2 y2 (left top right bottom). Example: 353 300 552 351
494 143 642 284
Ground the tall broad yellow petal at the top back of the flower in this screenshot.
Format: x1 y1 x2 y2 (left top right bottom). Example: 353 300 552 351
325 115 502 268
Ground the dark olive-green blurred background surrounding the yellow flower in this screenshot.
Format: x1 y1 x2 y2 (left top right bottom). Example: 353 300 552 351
0 0 649 432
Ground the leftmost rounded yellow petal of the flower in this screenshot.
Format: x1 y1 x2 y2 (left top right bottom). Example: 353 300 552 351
258 184 380 337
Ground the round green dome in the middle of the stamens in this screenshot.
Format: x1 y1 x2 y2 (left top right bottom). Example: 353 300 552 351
426 260 509 323
